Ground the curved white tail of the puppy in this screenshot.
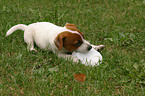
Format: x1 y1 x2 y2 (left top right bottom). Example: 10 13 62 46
6 24 27 36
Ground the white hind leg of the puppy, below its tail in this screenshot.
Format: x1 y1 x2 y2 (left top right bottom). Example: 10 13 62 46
24 30 37 52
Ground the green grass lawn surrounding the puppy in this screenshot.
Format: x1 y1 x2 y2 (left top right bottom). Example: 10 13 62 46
0 0 145 96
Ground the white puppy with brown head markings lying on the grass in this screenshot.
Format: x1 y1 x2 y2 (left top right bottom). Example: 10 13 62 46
6 22 104 60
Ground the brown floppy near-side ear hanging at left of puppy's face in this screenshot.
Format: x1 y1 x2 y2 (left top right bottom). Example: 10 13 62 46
54 34 65 50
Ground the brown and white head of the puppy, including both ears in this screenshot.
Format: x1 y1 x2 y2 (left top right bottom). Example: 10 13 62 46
54 23 92 52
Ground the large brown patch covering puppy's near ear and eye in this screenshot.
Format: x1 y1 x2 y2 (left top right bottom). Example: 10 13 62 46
54 31 83 52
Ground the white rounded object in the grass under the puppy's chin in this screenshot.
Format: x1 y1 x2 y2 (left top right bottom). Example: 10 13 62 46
72 48 102 66
